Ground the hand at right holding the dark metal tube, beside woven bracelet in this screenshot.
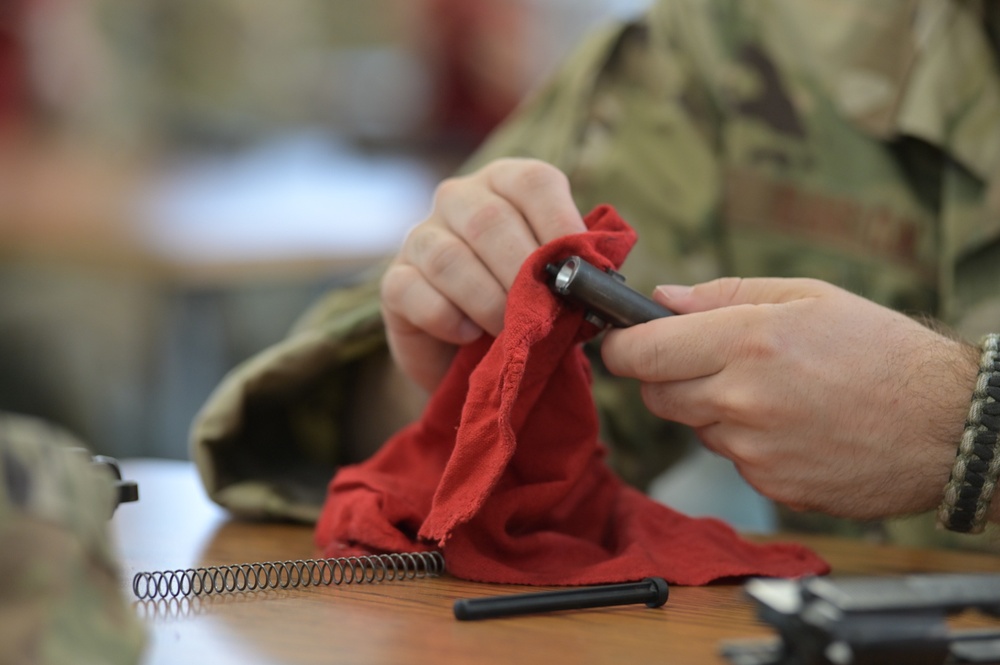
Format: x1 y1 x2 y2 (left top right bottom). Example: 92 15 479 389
602 278 978 519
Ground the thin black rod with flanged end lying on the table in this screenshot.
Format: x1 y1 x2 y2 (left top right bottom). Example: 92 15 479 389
454 577 670 621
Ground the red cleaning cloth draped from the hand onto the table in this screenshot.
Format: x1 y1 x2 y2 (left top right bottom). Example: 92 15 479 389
316 206 829 585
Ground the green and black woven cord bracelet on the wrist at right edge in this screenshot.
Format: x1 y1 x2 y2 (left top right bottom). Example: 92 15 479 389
938 333 1000 533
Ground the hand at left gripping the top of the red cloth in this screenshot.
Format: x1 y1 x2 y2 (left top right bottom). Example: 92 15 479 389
381 159 586 391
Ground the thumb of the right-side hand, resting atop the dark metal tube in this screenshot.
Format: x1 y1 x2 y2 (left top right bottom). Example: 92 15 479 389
653 277 832 314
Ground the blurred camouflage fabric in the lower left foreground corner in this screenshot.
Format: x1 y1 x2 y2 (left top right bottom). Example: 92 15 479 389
0 414 145 665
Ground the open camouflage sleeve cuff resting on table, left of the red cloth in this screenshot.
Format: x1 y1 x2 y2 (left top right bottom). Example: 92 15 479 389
191 268 396 521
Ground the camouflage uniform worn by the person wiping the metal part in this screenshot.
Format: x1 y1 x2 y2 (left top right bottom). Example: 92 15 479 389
193 0 1000 544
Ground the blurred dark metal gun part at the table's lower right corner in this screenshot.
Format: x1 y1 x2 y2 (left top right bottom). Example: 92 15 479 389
721 574 1000 665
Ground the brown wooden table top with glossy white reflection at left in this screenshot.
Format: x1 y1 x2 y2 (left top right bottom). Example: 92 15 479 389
113 460 1000 665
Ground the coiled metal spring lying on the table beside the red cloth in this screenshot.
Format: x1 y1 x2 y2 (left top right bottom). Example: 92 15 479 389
132 552 444 600
